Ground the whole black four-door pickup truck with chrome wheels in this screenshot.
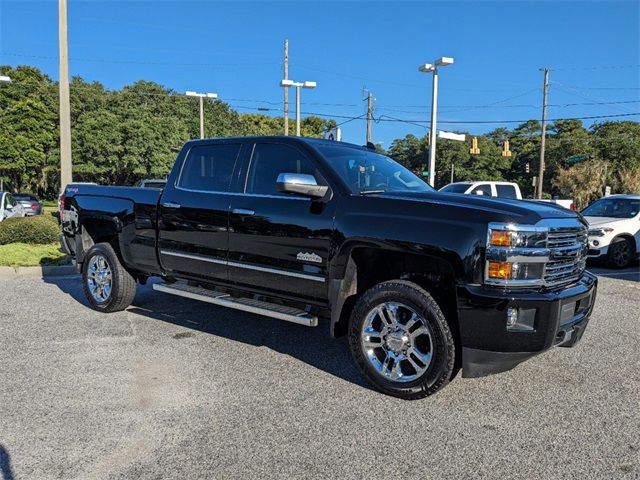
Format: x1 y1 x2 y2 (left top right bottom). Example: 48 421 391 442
60 137 597 399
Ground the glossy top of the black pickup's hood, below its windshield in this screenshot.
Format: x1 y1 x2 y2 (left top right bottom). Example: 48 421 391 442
378 192 584 225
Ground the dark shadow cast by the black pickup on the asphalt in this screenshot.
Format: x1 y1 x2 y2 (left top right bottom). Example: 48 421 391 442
45 276 372 390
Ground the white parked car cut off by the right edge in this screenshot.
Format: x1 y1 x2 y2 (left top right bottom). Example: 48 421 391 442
581 195 640 268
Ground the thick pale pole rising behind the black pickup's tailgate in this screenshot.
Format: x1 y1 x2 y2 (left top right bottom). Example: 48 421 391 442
58 0 73 190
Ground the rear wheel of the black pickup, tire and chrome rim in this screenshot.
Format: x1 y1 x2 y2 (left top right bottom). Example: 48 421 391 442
82 243 136 313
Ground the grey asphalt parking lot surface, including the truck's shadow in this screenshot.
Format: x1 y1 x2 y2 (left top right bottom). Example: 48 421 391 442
0 267 640 480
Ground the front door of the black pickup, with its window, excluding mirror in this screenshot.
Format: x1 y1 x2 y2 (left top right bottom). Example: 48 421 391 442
229 142 335 302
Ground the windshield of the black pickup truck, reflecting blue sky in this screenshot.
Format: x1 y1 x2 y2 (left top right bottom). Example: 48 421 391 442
316 145 434 193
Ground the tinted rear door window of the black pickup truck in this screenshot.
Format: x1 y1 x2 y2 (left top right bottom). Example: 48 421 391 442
178 144 240 192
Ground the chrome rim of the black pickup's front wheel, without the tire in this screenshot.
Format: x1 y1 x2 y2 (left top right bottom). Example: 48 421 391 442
360 302 433 382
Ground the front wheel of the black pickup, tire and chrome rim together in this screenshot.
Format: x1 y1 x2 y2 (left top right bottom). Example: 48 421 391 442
349 280 456 400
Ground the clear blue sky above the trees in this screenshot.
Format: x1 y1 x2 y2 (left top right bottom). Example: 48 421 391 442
0 0 640 147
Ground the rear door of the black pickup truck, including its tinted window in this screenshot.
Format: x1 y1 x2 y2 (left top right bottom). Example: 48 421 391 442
158 141 242 280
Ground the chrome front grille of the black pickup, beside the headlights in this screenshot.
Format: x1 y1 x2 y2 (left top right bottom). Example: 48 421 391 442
544 227 588 286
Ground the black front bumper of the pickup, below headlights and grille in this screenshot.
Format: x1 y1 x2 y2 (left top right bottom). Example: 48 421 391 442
457 272 598 377
